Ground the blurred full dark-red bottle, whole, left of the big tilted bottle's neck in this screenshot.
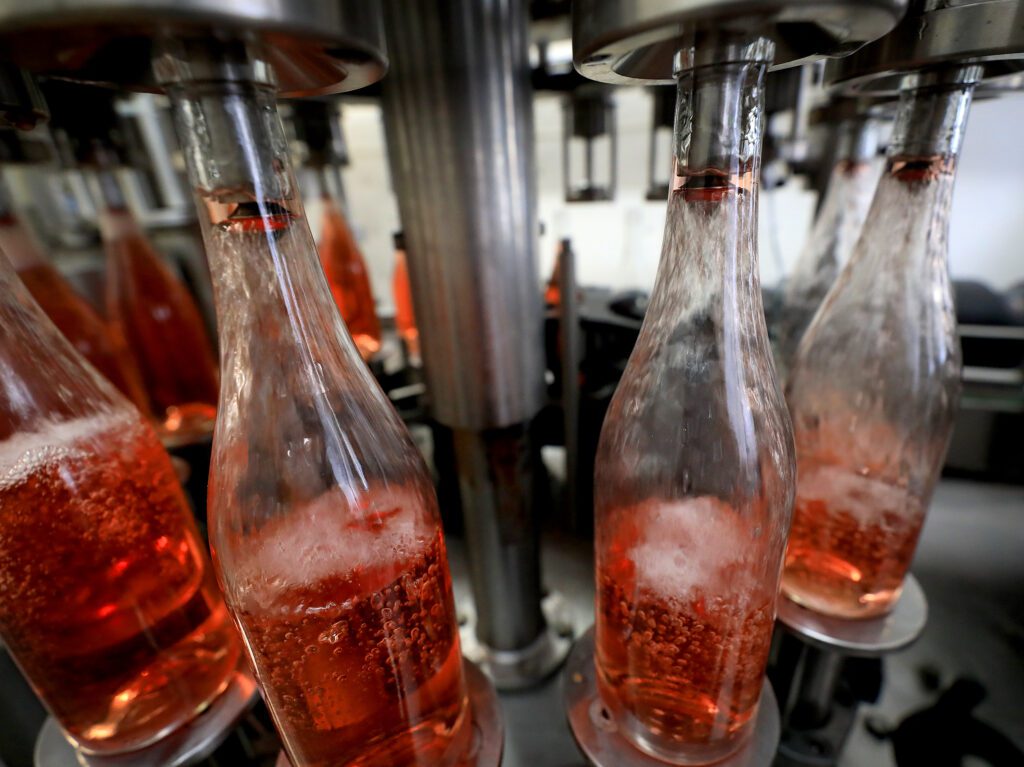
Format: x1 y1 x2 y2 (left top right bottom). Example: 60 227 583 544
91 156 217 441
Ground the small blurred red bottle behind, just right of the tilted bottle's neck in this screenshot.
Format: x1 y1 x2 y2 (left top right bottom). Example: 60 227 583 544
319 166 381 361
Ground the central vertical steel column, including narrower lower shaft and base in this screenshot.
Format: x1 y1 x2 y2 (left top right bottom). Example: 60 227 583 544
382 0 567 687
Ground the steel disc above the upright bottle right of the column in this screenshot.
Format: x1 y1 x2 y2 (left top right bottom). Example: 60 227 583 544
572 0 907 85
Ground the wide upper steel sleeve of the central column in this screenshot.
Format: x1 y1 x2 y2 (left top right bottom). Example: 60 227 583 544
383 0 544 429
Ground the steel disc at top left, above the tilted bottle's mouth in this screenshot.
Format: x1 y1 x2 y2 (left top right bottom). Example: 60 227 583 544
0 0 387 95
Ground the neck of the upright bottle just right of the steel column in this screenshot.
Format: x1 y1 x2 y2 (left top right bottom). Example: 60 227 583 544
648 46 770 333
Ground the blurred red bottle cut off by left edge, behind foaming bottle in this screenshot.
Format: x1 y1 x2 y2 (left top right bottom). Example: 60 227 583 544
0 200 150 416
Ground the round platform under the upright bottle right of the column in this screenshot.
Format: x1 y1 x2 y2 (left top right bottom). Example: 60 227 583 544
564 628 779 767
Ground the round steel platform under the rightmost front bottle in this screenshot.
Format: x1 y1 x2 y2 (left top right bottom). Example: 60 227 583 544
778 574 928 657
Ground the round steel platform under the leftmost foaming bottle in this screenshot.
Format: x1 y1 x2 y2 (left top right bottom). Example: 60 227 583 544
34 671 259 767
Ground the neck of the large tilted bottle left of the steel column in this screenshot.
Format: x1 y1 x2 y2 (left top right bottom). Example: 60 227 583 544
157 46 358 380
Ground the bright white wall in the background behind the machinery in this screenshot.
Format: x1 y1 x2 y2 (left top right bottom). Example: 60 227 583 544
335 88 1024 314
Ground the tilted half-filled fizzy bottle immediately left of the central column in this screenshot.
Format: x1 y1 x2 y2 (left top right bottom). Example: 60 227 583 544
157 42 472 767
